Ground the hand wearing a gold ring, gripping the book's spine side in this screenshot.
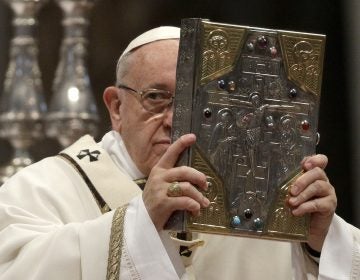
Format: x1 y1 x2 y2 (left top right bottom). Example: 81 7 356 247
143 134 210 231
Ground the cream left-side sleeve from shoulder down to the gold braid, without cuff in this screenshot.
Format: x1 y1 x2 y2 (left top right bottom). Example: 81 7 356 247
0 159 118 280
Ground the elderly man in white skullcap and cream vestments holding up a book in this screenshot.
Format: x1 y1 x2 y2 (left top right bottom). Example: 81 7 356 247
0 27 360 280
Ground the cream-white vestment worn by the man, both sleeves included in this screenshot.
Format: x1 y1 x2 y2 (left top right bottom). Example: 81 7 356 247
0 132 360 280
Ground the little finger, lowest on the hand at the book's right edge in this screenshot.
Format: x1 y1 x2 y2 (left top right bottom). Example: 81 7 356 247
292 196 337 217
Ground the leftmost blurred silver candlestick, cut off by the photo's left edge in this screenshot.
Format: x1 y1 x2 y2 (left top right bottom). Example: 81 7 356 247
0 0 47 184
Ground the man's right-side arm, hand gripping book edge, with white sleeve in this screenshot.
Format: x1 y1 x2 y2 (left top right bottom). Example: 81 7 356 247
289 155 360 279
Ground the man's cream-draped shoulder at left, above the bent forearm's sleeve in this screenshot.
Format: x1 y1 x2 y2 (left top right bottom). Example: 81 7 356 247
0 156 98 221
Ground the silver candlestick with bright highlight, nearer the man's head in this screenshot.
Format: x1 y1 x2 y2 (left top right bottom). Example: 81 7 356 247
46 0 99 147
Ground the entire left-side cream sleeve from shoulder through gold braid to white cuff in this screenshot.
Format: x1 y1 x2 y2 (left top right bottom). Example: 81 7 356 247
0 158 186 280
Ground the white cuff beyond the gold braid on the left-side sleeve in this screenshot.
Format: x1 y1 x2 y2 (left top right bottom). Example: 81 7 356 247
120 196 186 280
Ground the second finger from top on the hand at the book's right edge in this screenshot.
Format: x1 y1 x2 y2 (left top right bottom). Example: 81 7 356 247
290 167 329 196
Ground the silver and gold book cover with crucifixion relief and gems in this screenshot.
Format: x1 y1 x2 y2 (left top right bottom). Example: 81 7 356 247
168 19 325 241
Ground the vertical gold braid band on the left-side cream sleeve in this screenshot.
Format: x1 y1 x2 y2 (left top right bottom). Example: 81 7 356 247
106 205 127 280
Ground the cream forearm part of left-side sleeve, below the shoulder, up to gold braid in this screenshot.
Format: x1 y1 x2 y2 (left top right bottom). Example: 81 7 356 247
0 196 113 280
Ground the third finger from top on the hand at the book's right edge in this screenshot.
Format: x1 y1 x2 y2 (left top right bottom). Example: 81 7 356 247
288 180 333 206
